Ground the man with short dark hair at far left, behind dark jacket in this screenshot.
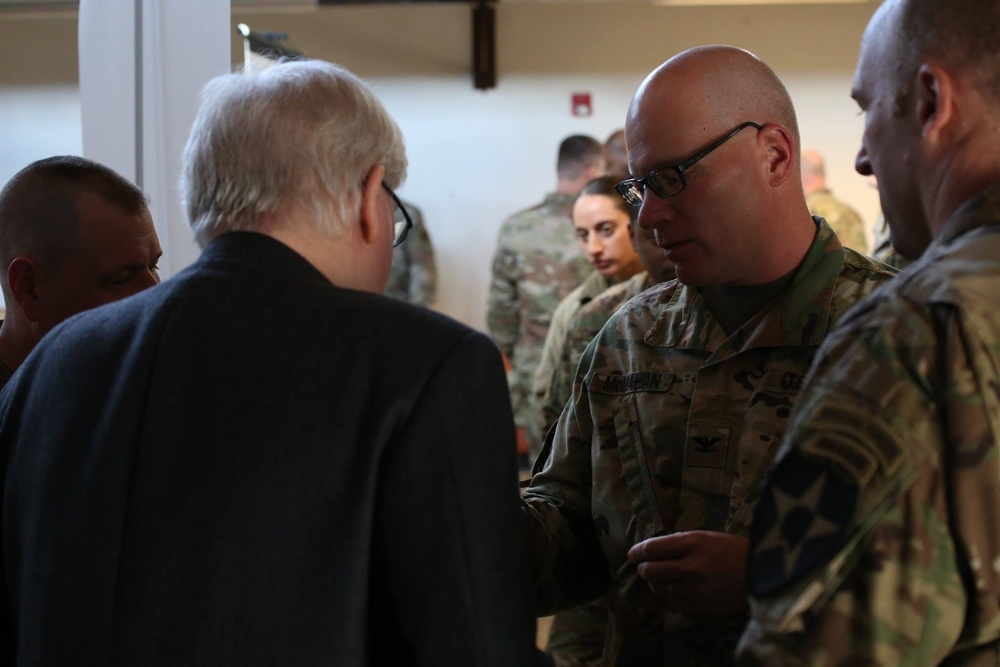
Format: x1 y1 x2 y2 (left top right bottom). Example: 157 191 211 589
0 155 163 387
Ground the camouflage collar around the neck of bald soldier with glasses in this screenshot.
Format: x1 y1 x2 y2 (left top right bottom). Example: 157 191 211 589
645 219 844 363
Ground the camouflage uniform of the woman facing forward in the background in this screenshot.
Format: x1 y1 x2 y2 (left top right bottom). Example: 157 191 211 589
528 271 611 461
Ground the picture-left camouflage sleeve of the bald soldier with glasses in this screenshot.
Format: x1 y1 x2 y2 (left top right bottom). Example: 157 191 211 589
522 340 610 615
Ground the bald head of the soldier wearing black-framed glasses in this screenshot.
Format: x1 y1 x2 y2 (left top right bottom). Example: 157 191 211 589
625 46 815 285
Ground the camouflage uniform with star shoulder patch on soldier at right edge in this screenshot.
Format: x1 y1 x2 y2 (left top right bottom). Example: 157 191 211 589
741 185 1000 666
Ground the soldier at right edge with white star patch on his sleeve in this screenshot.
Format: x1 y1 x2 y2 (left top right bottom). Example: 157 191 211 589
740 0 1000 666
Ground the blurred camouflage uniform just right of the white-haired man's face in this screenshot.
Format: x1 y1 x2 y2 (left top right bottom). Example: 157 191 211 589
384 202 437 307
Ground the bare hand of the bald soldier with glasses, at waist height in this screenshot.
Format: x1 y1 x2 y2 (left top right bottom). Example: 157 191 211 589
628 530 749 614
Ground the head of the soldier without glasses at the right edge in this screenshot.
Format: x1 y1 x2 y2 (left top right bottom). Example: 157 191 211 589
852 0 1000 258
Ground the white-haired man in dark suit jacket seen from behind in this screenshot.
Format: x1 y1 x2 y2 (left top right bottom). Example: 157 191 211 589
0 61 534 667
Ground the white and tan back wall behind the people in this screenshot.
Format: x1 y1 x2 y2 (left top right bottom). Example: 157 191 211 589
0 2 878 328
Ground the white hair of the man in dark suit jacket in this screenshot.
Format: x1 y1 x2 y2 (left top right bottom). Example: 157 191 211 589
181 60 406 245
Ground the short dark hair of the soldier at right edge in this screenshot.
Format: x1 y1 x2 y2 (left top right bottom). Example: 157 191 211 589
896 0 1000 103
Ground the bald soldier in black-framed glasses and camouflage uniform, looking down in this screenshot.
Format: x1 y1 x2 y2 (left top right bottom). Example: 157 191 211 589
522 46 892 666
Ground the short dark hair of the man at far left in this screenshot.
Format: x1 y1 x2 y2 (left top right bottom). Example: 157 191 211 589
0 155 149 290
